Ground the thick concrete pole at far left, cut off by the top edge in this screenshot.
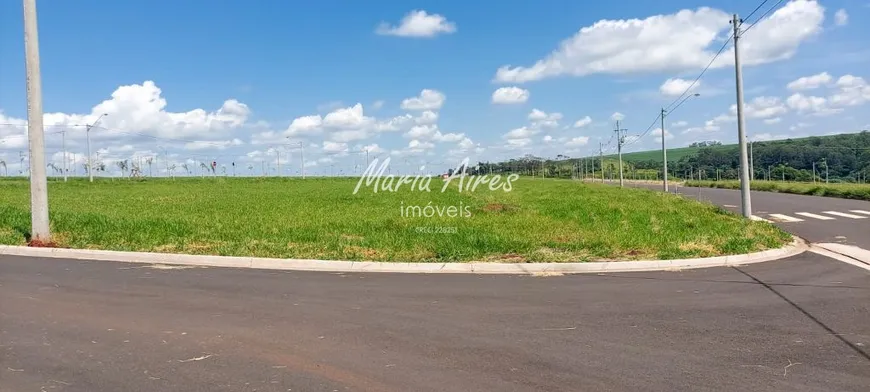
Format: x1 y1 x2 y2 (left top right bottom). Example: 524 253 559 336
24 0 51 243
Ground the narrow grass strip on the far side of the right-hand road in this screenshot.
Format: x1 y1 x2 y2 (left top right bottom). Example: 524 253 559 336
685 181 870 201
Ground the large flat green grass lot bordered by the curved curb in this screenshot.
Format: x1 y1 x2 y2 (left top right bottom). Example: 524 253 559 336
0 178 789 262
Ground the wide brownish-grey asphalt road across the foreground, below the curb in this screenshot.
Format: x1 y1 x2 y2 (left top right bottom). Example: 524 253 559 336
0 253 870 392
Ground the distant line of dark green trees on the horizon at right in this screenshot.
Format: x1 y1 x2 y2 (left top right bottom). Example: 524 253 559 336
461 131 870 182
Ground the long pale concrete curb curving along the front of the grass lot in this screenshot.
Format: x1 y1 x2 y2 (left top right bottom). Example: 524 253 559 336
0 237 809 275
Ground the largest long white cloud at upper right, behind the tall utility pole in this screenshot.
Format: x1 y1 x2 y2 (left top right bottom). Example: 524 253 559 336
495 0 824 83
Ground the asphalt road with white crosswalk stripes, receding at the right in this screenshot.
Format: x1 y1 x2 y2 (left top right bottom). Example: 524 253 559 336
631 184 870 249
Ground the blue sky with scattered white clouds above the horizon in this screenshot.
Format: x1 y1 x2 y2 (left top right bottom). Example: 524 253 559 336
0 0 870 173
